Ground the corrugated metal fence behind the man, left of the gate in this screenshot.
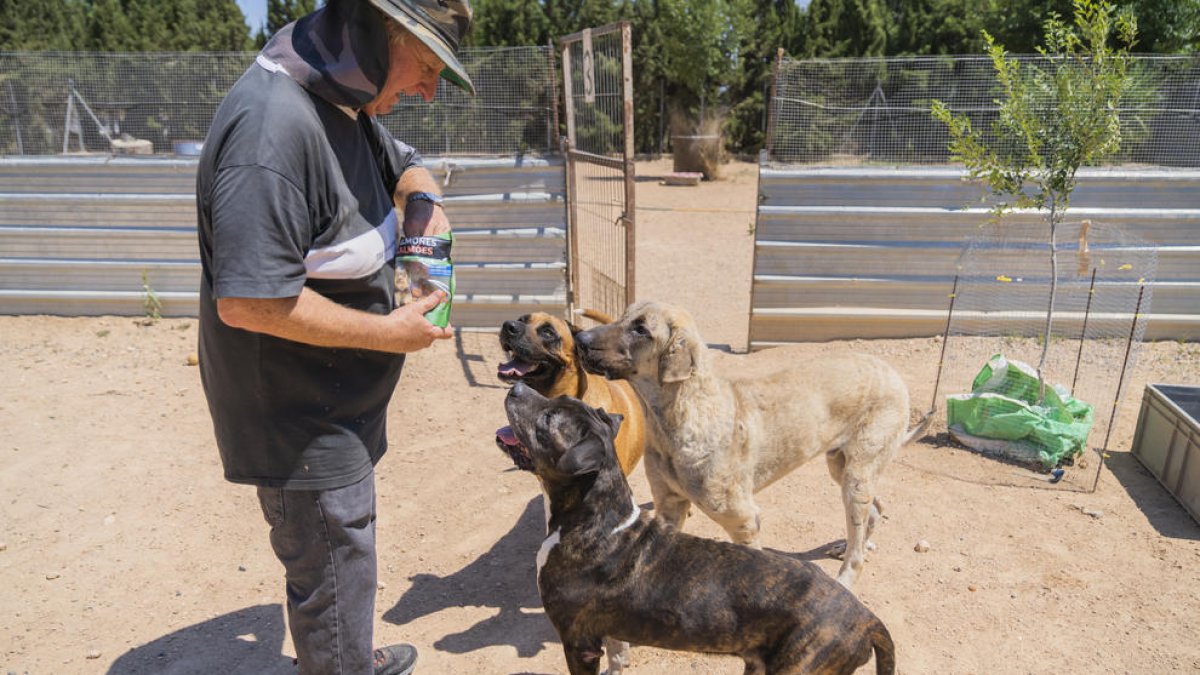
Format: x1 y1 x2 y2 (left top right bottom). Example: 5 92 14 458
0 156 566 328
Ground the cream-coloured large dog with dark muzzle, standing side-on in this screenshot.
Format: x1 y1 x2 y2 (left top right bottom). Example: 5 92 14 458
575 303 928 587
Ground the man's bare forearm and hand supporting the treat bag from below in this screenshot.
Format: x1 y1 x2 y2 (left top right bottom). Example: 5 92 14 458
217 288 454 353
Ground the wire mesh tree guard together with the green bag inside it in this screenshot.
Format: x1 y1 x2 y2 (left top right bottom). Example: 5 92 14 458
934 221 1158 468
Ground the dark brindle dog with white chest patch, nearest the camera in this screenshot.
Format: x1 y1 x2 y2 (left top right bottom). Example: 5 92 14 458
504 383 895 675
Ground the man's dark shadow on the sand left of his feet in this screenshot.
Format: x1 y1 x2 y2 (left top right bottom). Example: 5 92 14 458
108 604 295 675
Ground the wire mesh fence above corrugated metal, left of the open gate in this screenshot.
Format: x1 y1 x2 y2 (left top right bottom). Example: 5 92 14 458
0 46 557 155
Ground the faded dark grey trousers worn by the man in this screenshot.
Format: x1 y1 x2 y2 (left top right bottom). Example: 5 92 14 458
258 472 377 675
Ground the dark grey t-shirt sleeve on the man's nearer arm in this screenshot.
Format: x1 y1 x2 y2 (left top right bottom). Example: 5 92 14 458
211 165 313 298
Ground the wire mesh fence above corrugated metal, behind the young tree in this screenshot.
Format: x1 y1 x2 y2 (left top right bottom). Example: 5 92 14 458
768 55 1200 167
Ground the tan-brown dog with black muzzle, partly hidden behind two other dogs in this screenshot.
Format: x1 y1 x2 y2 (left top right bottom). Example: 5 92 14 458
497 311 646 476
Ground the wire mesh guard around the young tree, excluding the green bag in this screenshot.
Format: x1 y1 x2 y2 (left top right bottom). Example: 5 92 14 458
935 219 1158 470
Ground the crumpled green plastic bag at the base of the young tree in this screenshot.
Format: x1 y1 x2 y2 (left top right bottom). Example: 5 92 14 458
946 354 1093 468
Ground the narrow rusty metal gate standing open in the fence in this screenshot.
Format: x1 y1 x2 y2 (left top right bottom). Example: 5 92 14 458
559 22 635 317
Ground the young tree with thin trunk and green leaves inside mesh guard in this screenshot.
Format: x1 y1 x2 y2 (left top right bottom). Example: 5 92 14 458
932 0 1136 395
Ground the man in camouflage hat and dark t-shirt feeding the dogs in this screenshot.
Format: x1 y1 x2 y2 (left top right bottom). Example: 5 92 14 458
197 0 474 675
